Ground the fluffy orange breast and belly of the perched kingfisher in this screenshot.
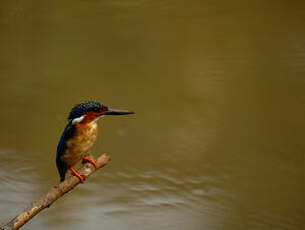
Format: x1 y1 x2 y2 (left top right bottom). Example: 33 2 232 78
62 122 97 167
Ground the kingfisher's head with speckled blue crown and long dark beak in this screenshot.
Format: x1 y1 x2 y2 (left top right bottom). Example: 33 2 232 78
68 101 134 123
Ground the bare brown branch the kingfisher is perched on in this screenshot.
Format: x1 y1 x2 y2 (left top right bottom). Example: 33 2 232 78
0 154 110 230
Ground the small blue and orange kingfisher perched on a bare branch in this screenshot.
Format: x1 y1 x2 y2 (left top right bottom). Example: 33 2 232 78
56 101 134 183
